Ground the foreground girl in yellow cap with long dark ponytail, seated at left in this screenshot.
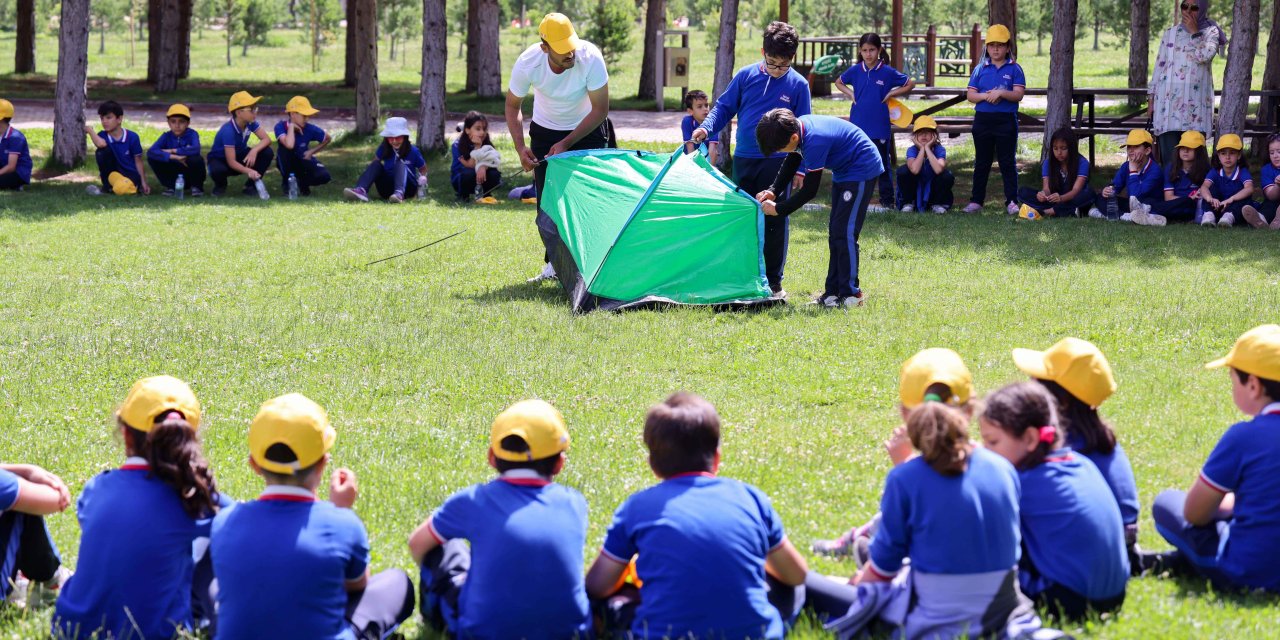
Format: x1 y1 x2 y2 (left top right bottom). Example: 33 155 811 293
52 375 225 639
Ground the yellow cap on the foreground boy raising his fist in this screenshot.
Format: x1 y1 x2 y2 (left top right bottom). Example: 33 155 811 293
248 393 338 475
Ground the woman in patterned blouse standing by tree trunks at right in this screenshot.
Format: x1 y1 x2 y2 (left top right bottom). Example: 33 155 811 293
1147 0 1226 161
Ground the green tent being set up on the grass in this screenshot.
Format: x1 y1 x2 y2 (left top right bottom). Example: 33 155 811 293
538 148 778 312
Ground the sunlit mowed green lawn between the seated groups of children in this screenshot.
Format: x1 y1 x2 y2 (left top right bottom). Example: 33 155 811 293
0 129 1280 639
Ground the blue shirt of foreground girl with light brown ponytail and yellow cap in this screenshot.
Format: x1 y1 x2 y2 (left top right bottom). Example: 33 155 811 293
869 447 1021 577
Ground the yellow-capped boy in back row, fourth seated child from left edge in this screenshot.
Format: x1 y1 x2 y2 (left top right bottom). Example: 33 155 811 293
209 91 274 196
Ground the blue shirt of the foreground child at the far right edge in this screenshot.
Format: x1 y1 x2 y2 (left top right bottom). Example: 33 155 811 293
1201 402 1280 591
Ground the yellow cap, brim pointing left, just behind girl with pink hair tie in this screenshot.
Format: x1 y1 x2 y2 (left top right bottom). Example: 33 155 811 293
1014 338 1116 407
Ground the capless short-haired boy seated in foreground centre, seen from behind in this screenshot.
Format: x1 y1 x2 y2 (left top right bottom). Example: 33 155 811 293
586 393 808 639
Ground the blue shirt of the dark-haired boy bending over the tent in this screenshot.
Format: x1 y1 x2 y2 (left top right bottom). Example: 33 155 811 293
797 115 884 182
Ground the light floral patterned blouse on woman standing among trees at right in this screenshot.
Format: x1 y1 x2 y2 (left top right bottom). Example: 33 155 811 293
1147 24 1222 140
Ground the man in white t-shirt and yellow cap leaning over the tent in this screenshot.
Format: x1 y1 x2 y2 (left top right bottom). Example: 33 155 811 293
507 13 617 282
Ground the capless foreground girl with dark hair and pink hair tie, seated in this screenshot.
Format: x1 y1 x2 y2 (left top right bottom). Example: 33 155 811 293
978 383 1129 620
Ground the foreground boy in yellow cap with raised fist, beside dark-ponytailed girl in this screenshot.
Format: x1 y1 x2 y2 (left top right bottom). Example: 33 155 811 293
210 393 413 640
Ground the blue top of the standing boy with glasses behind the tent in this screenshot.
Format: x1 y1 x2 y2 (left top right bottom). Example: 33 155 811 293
698 61 810 157
